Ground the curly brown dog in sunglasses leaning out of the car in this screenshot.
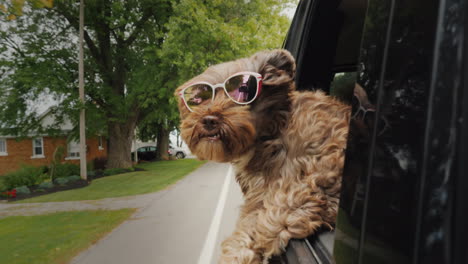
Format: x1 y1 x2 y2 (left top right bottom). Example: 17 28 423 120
175 50 350 264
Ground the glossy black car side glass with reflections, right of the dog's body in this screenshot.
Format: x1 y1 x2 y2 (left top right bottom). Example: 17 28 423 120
335 0 443 264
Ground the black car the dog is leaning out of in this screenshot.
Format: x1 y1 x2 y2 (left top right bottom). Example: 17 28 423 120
275 0 468 264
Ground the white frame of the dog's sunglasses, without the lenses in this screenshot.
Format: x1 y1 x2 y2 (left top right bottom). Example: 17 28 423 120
179 72 262 112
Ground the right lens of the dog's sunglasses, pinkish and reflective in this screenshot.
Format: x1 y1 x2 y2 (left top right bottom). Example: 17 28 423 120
225 74 258 103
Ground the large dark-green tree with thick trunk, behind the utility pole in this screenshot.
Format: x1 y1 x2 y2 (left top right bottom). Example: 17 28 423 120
0 0 172 168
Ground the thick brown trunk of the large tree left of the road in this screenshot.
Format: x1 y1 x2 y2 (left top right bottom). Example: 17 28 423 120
107 121 135 168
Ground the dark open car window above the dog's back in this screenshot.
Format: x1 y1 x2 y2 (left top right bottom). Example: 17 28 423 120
285 0 367 94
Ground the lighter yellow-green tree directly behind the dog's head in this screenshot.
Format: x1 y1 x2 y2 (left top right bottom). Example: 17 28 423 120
139 0 294 155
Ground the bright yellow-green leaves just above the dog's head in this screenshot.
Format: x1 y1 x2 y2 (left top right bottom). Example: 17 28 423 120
161 0 289 84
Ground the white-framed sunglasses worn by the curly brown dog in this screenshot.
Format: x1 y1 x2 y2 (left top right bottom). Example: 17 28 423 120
179 72 262 112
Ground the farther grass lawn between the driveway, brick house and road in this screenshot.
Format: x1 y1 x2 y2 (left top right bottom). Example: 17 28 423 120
16 159 205 203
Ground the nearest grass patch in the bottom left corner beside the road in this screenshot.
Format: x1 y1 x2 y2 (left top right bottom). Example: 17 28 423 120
0 209 135 264
